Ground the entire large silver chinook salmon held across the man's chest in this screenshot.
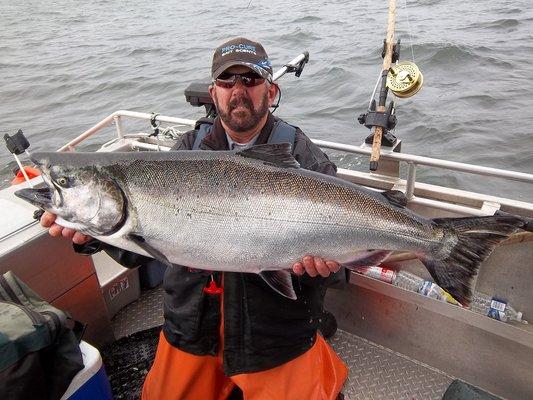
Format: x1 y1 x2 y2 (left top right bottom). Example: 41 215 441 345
15 144 524 304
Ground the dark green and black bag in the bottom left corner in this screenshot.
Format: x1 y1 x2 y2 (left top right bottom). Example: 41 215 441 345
0 271 83 400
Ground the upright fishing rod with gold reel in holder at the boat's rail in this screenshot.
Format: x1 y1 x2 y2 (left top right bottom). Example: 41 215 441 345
359 0 423 171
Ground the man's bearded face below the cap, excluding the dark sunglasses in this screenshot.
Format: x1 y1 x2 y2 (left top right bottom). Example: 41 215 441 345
210 66 277 132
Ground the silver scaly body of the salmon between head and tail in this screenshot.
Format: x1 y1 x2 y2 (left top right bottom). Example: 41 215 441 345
107 152 434 272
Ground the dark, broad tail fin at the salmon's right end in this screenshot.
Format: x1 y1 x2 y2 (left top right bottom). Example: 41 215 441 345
420 216 524 305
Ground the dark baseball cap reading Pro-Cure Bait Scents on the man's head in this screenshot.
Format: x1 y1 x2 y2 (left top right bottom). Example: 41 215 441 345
211 37 272 80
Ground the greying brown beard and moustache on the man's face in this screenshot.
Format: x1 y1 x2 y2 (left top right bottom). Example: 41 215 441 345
215 92 268 132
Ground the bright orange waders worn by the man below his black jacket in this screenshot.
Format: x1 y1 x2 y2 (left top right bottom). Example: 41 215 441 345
142 278 348 400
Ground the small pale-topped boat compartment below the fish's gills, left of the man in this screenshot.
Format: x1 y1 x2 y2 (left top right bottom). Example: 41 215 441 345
92 251 141 318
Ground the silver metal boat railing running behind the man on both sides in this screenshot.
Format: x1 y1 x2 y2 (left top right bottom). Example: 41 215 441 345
58 110 533 216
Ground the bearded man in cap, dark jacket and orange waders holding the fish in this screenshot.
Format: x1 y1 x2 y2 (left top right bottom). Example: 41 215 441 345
42 38 347 400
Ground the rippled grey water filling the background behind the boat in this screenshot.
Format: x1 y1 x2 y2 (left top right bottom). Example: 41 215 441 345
0 0 533 201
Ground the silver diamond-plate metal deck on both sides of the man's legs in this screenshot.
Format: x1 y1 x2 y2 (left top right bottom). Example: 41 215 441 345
112 287 454 400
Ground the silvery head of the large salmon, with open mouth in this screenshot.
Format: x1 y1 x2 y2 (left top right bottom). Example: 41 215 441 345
15 153 127 235
